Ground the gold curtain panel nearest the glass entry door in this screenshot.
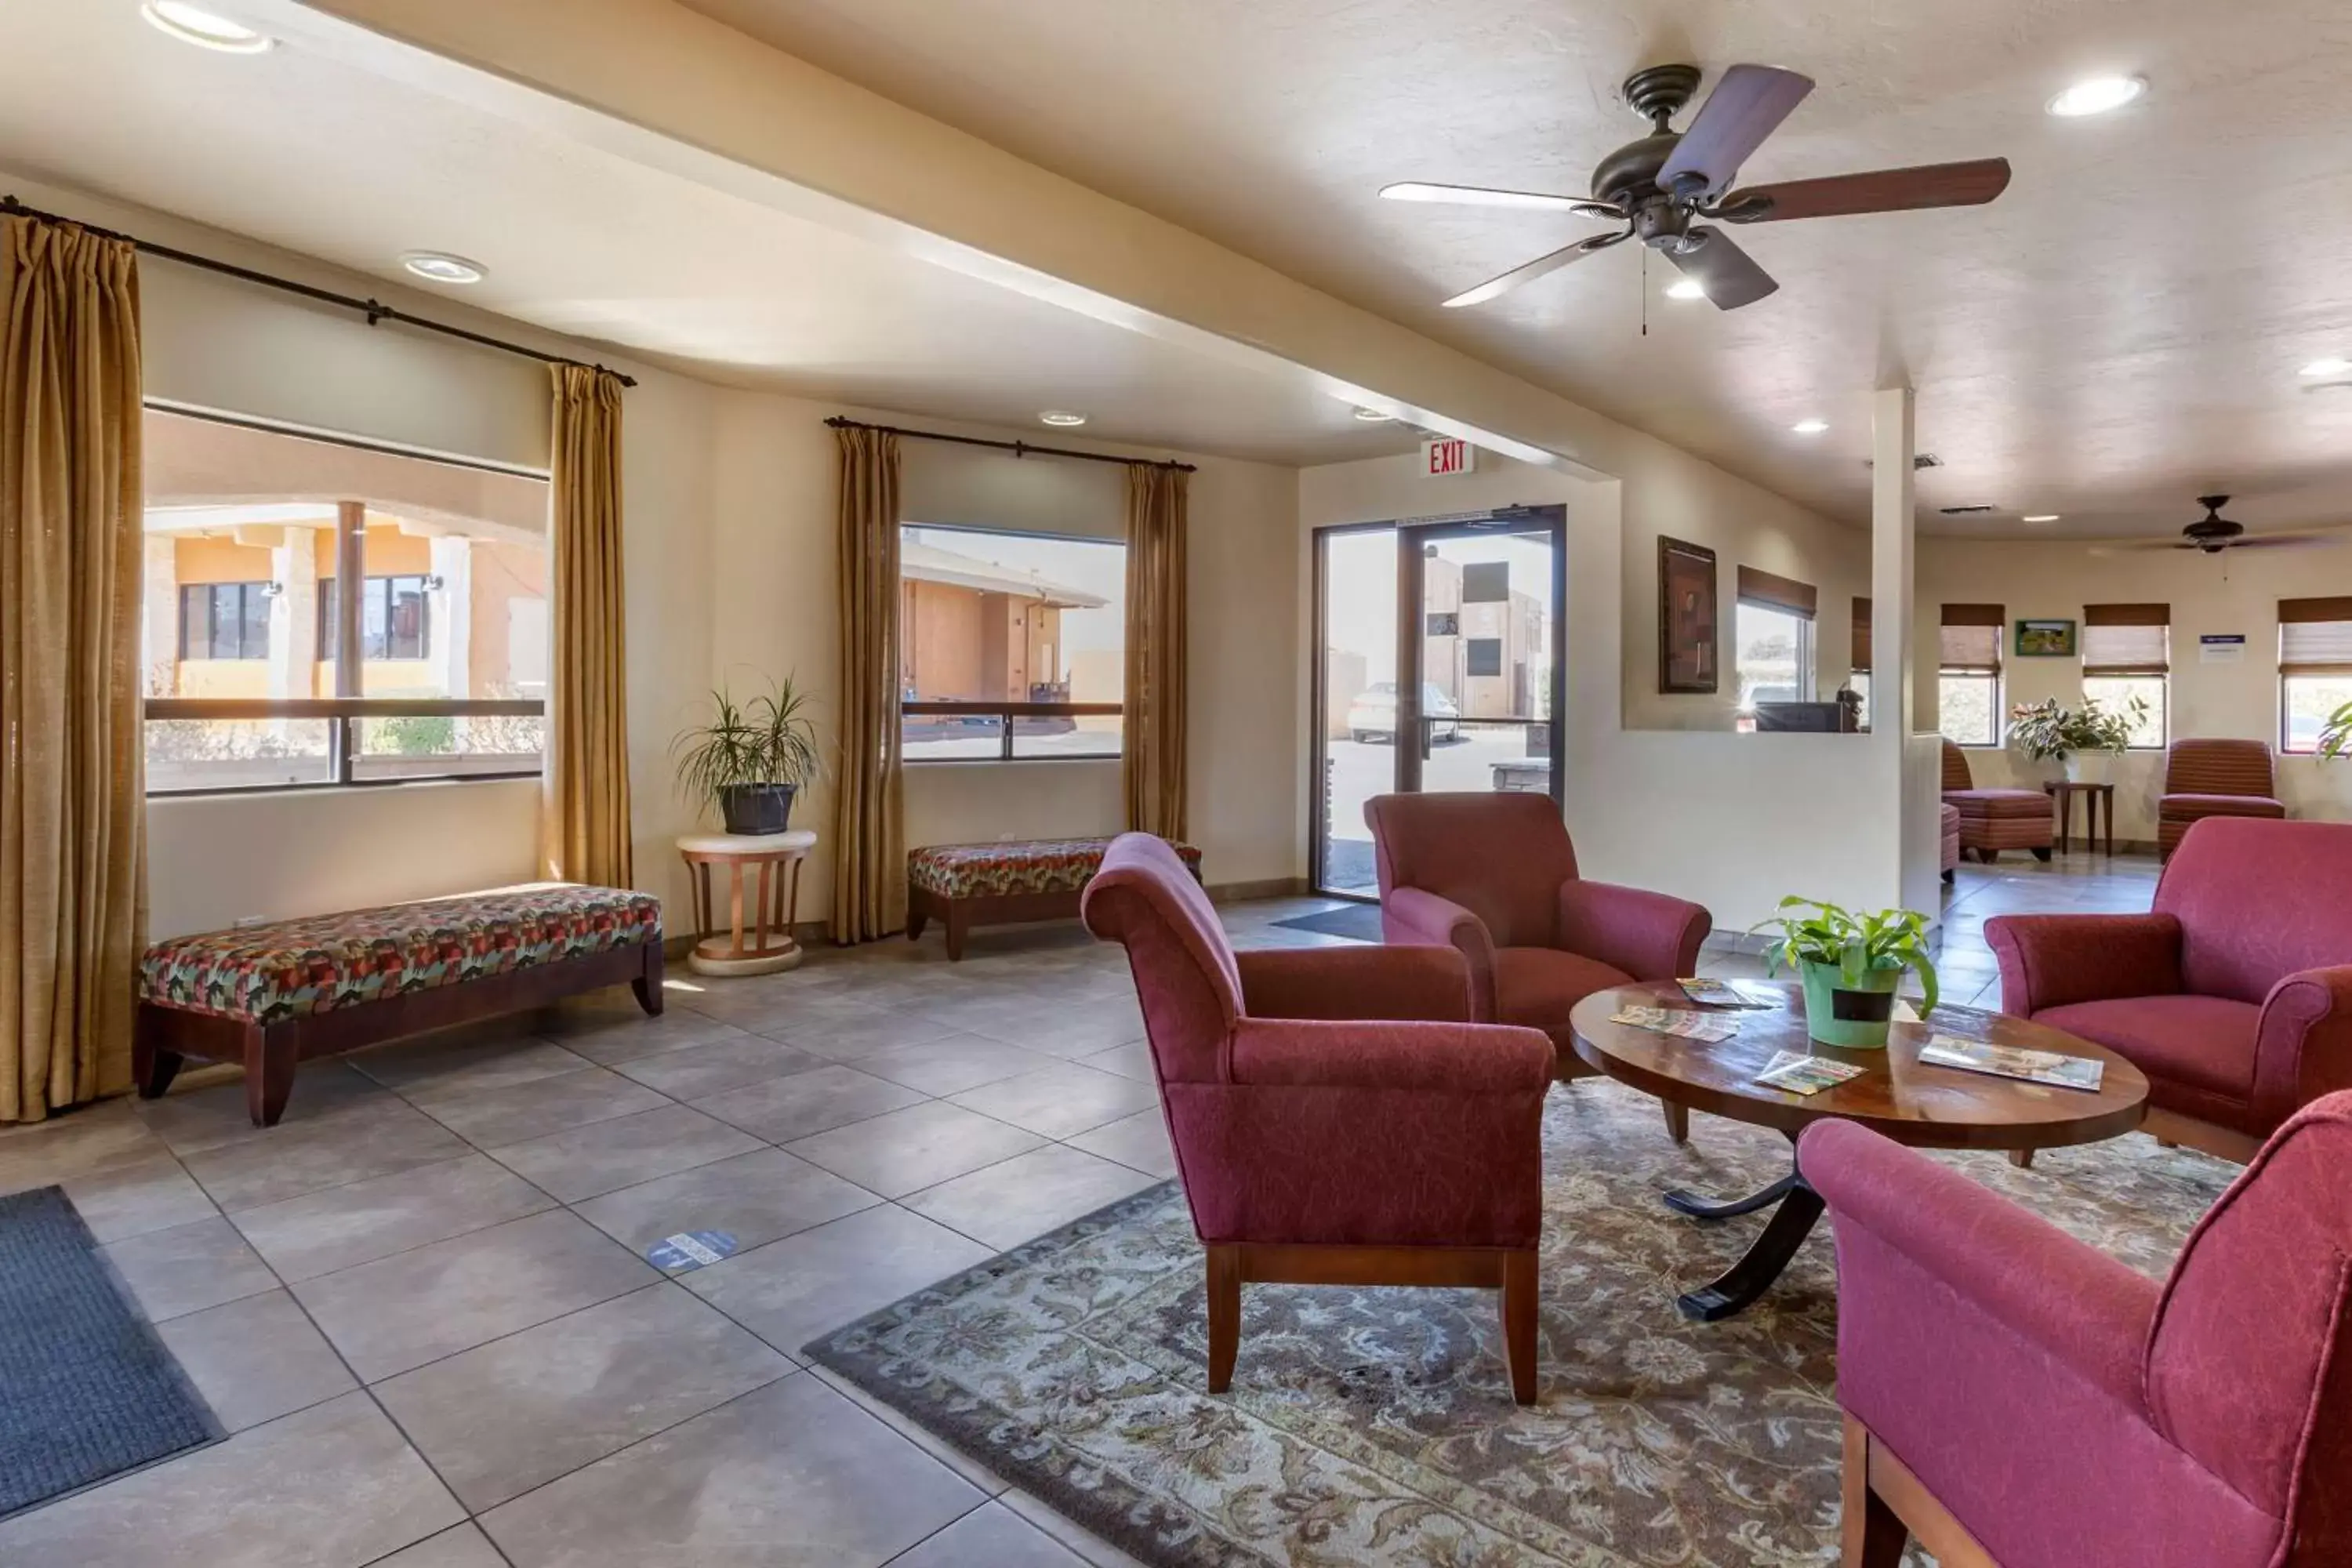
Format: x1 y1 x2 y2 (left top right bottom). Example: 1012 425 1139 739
1120 463 1192 839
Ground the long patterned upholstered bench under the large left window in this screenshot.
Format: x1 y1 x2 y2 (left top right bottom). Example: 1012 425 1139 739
132 881 661 1126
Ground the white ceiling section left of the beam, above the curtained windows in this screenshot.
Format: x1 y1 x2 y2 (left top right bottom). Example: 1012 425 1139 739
0 0 1414 463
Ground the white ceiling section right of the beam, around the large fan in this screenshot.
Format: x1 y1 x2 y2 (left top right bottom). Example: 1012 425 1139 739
687 0 2352 536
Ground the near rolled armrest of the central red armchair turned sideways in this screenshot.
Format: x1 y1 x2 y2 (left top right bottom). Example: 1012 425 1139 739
1230 1018 1552 1102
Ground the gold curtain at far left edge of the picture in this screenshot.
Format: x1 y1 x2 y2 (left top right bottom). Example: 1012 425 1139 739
0 219 146 1121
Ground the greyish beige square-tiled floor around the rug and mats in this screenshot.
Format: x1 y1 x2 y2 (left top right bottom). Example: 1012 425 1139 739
0 855 2154 1568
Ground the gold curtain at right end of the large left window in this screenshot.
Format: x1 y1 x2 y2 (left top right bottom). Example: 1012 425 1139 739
539 365 630 888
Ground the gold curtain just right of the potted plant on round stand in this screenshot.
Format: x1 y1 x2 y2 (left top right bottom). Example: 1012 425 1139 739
833 428 906 942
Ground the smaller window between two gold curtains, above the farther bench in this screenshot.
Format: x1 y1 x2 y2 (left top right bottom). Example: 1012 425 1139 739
898 522 1127 762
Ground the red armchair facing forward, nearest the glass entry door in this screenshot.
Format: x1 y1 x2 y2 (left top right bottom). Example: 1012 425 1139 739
1364 794 1715 1109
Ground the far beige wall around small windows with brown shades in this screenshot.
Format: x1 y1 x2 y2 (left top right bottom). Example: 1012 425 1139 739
1917 529 2352 841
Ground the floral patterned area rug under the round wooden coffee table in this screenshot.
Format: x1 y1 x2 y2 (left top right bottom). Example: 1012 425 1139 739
809 1079 2234 1568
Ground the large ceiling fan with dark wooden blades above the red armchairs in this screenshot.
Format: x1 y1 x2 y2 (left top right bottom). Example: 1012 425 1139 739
1381 66 2009 310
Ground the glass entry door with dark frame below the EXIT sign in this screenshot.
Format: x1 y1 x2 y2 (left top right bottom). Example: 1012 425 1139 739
1315 508 1566 898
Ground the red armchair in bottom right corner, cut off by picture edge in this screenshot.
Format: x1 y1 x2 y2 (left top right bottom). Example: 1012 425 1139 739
1799 1093 2352 1568
